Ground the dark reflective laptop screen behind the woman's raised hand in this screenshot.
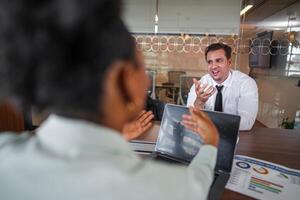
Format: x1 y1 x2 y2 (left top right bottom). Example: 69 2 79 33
155 104 240 172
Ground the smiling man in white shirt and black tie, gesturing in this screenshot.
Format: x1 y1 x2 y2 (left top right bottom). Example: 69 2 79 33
187 43 258 130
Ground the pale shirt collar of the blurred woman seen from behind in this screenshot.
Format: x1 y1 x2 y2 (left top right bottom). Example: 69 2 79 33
37 114 135 157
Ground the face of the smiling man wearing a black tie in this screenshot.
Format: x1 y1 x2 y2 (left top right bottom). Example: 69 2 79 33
206 49 231 84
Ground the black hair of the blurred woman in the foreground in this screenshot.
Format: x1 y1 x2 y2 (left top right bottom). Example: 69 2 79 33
0 0 135 113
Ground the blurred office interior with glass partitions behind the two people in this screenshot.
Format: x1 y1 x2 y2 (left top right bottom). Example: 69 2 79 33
0 0 300 131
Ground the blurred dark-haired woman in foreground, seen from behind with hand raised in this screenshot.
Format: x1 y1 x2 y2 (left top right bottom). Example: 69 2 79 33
0 0 218 200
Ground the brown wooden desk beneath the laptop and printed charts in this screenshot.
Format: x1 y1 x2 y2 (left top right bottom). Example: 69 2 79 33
138 126 300 200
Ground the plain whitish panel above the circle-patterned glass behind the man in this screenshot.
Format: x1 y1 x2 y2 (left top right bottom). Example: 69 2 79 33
124 0 241 35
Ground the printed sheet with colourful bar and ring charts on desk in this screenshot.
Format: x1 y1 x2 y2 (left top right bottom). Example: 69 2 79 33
226 155 300 200
